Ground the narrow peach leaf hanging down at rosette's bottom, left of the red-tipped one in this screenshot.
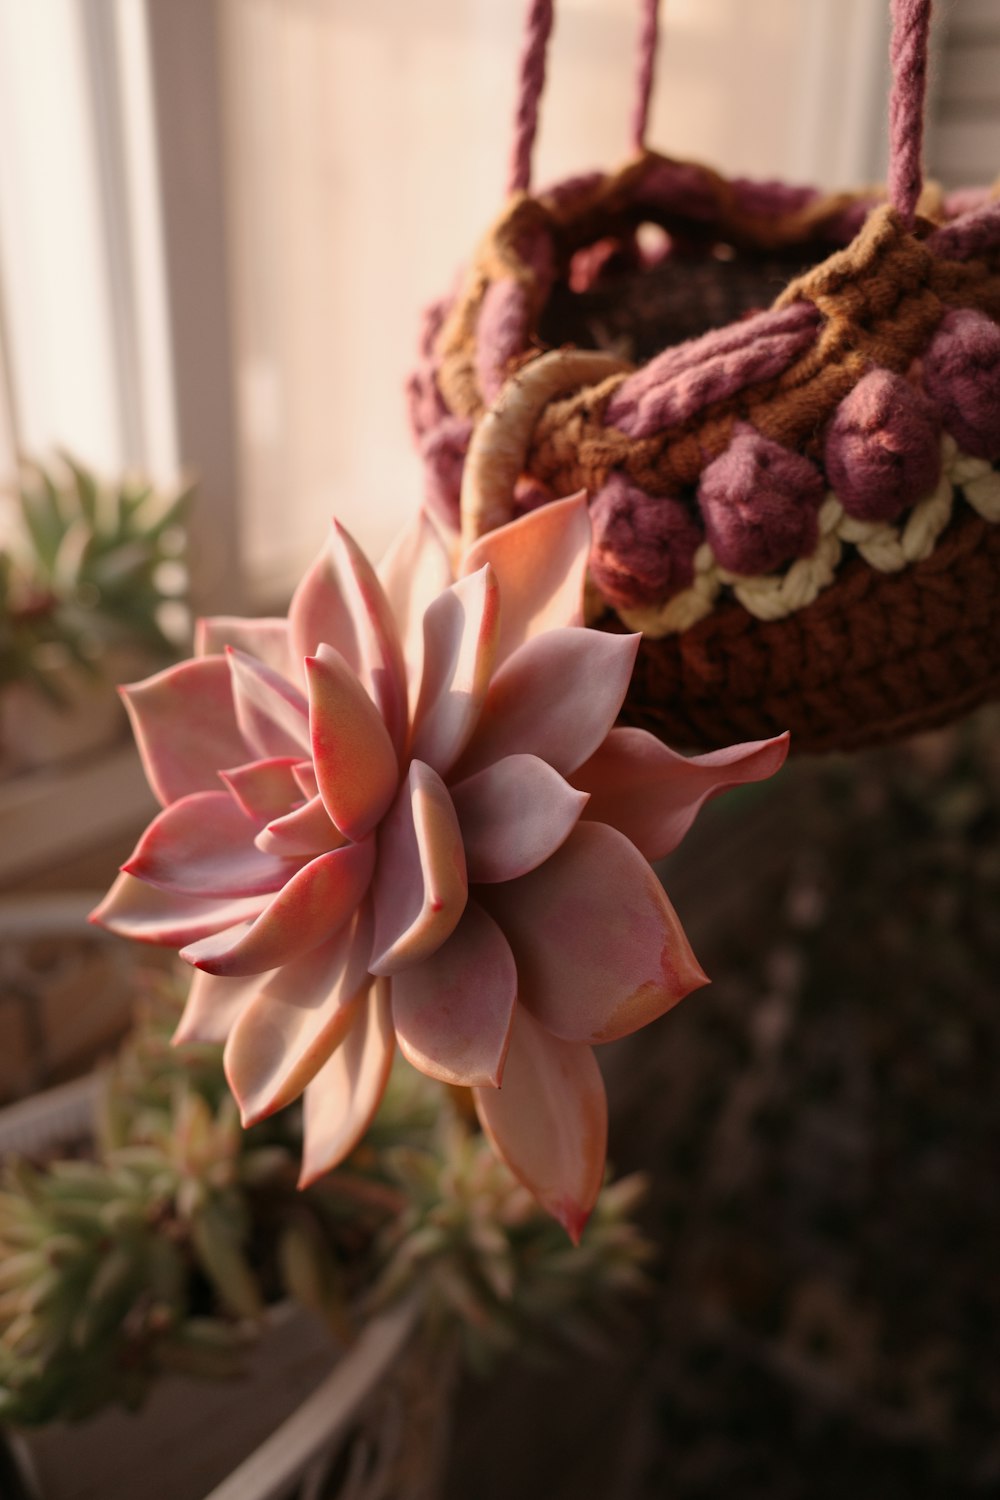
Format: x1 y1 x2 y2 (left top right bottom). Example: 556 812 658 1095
298 983 394 1188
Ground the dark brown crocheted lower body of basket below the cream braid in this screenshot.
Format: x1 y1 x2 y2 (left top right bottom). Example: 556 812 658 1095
614 509 1000 752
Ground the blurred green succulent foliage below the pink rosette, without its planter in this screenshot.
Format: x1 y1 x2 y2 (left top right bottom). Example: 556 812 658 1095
0 981 648 1425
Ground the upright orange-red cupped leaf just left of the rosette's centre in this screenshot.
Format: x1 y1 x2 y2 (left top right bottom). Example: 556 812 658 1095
306 647 399 839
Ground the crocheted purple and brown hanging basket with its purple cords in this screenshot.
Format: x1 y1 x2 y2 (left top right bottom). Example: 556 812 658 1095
411 0 1000 750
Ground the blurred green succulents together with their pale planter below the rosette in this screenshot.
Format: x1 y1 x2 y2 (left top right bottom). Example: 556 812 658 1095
0 978 646 1500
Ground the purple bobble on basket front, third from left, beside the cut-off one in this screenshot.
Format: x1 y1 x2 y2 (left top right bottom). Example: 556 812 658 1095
825 371 942 521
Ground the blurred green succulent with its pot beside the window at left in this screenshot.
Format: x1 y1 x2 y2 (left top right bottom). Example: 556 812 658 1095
0 455 190 771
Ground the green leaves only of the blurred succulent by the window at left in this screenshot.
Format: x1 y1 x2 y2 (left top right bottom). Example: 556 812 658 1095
0 455 192 702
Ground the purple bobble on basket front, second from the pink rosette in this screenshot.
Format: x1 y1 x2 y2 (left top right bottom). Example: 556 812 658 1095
699 428 825 576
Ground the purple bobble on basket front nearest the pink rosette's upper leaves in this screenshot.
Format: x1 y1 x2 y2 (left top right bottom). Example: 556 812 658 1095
591 474 702 606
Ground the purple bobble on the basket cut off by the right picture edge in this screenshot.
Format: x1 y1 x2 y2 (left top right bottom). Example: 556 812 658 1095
924 308 1000 464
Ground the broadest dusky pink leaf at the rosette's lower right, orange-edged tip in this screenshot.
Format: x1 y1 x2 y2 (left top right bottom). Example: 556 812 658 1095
477 822 708 1043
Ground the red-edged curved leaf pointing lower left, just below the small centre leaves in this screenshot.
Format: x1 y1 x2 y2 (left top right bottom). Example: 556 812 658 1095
181 839 375 978
